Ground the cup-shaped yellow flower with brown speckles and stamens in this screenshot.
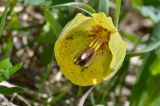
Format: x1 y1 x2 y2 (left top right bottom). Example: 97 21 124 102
54 13 127 86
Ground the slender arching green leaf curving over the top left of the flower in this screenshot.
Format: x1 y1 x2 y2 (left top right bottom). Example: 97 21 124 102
46 2 96 15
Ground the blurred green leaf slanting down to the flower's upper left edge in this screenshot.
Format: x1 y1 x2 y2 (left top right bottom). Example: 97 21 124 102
43 8 62 36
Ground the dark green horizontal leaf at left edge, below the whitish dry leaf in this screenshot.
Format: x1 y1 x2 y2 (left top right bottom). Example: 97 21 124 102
0 85 24 95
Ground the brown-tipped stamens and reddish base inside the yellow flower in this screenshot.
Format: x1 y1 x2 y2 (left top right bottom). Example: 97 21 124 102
73 26 111 68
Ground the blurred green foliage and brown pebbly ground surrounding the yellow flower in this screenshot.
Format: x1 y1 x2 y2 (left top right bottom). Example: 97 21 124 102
0 0 160 106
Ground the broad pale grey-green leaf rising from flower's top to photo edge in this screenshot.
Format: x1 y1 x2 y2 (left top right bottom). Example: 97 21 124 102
98 0 109 15
